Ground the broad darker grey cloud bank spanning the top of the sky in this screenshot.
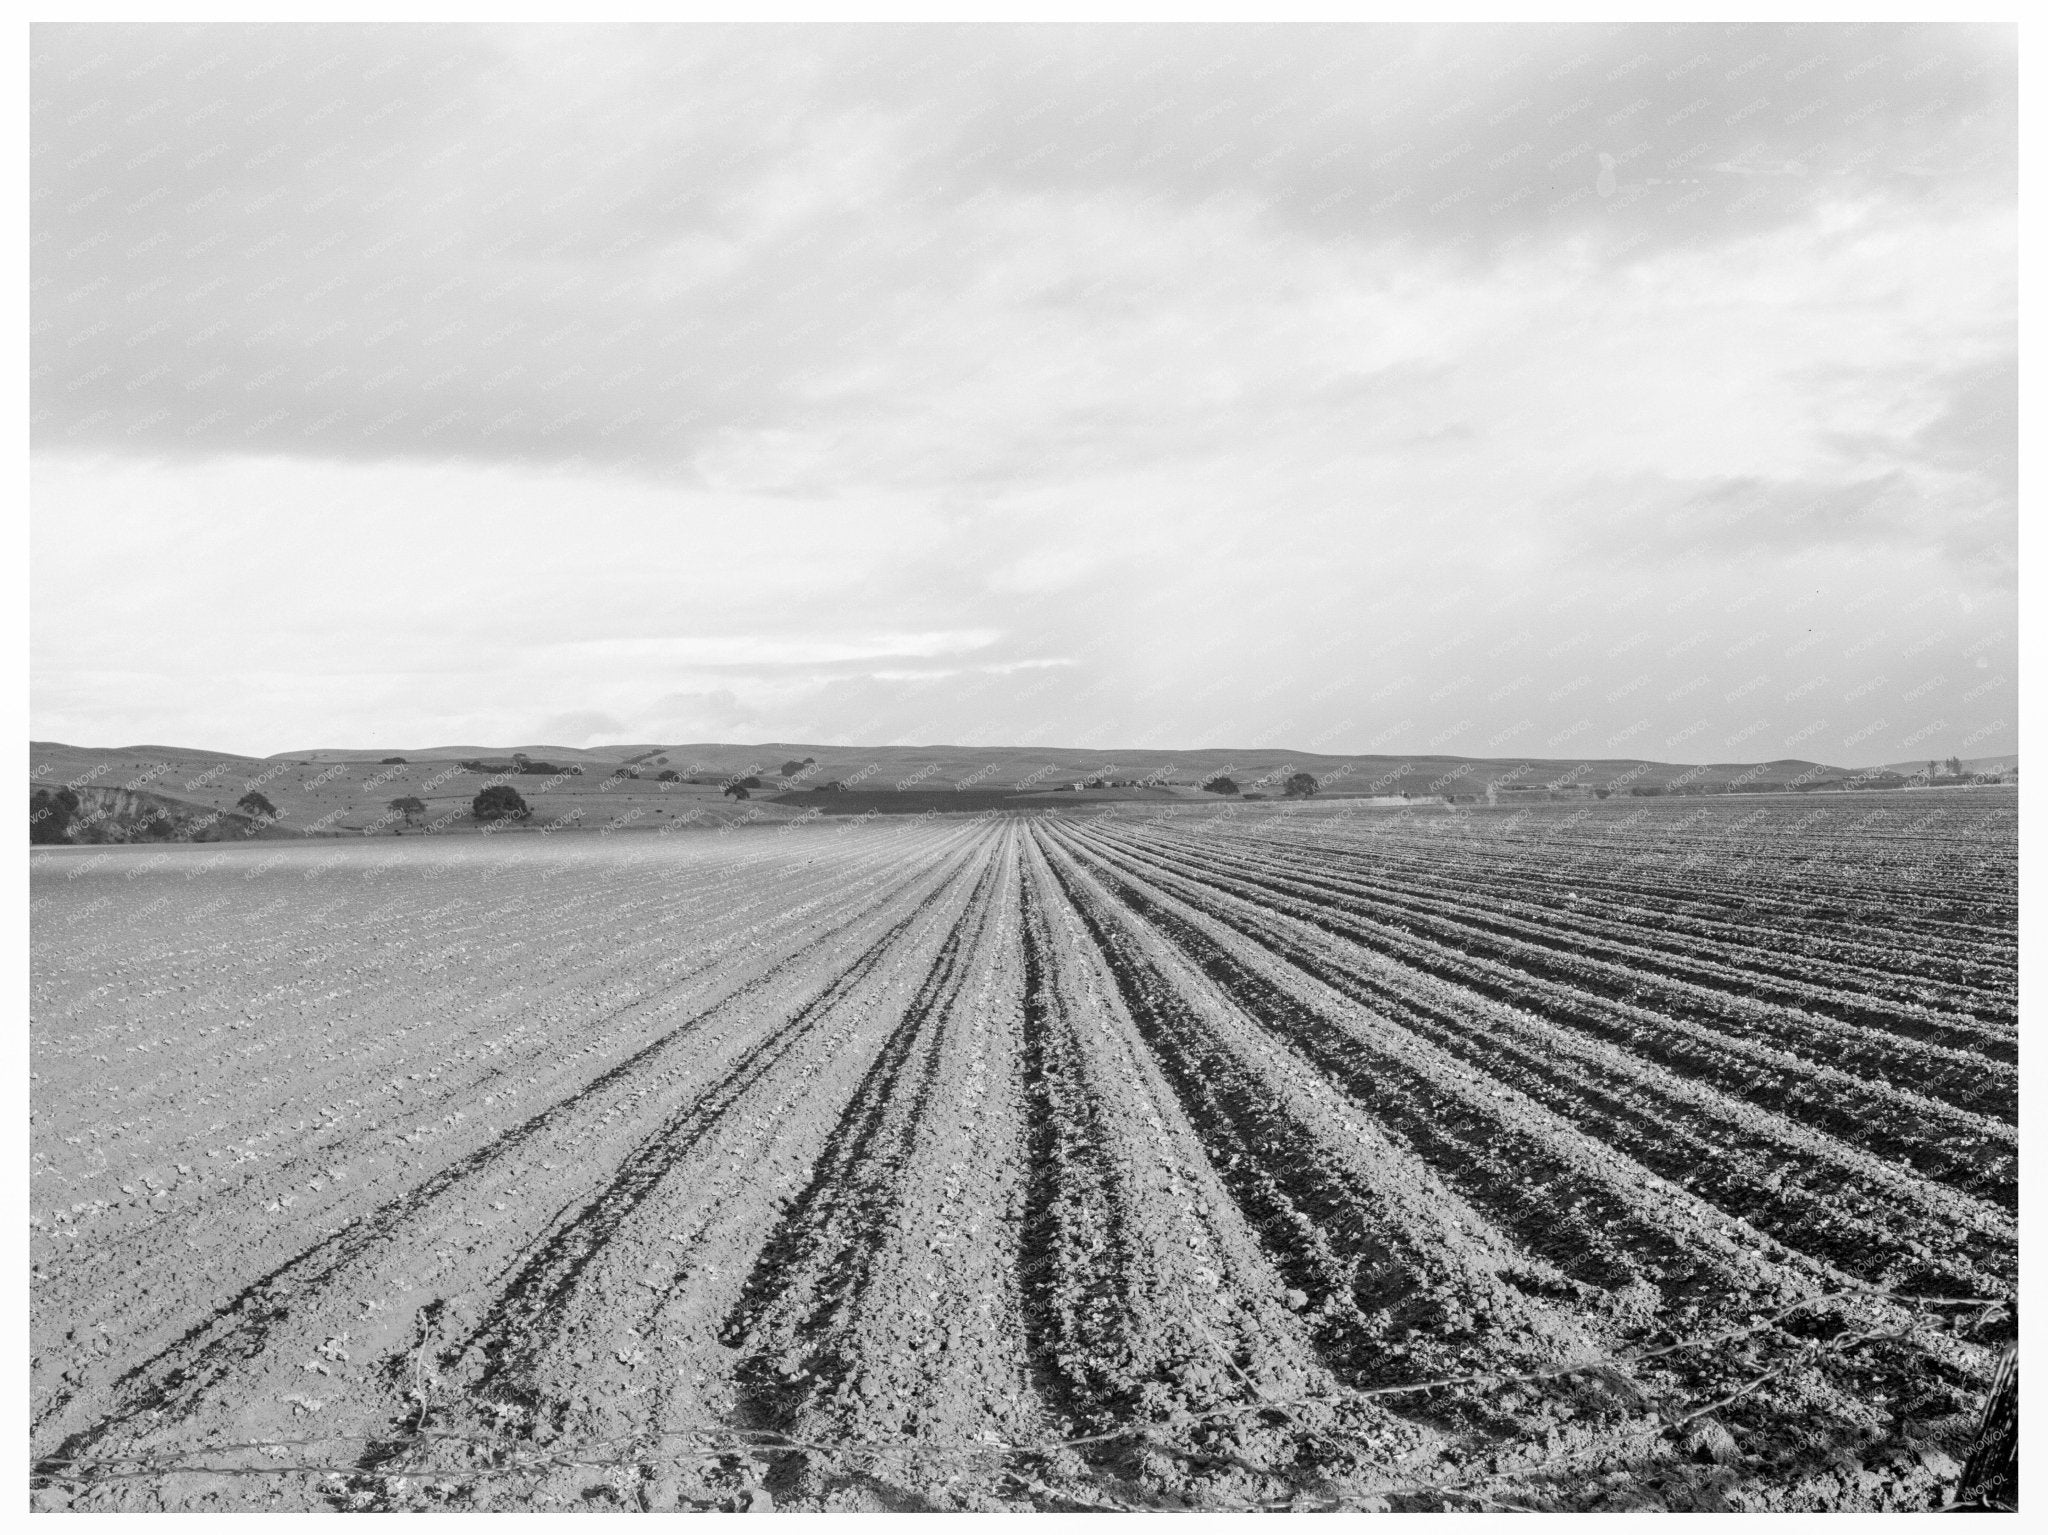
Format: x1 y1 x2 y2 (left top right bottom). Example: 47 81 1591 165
33 25 2013 474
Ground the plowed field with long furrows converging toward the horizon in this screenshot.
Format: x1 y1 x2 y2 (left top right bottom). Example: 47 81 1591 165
31 792 2017 1508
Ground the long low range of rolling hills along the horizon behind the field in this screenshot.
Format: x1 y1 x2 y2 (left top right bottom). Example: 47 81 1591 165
29 741 2015 839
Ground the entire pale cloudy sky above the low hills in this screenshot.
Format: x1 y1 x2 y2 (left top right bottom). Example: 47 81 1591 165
31 27 2017 765
